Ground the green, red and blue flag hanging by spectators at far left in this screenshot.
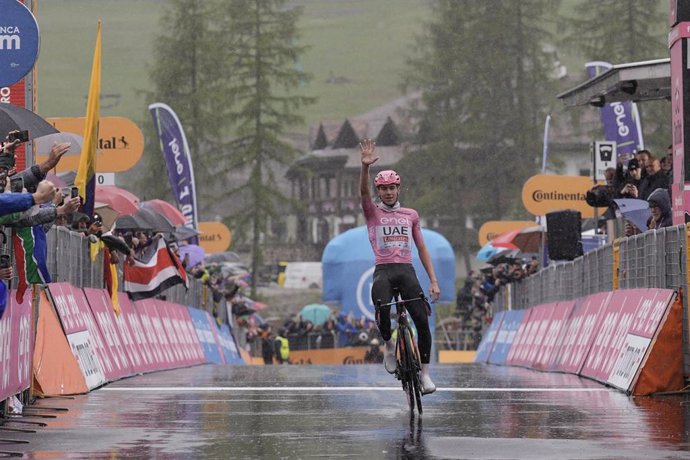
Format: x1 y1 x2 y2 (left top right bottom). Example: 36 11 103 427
12 225 50 303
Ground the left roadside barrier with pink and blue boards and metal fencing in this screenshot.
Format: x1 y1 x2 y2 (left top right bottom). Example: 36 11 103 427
0 227 246 427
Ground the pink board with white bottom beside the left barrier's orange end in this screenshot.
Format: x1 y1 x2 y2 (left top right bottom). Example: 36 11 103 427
48 283 106 390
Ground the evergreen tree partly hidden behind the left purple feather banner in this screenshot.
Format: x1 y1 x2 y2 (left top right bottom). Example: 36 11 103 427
126 0 224 207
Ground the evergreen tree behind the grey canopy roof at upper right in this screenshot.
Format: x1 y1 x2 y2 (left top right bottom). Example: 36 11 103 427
563 0 671 157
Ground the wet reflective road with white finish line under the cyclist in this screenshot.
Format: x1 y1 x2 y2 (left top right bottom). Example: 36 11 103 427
0 364 690 460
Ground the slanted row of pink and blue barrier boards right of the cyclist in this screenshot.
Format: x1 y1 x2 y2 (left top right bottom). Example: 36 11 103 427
476 288 684 395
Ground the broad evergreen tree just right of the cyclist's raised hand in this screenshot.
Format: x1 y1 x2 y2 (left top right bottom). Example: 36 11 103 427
401 0 558 270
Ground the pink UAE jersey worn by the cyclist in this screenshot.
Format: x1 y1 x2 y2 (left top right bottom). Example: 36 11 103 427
362 198 422 265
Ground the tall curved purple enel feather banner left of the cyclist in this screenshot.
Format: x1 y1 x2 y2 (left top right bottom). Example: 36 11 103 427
149 102 199 244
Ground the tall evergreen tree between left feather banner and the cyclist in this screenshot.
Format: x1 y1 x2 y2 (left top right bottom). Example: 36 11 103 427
210 0 313 293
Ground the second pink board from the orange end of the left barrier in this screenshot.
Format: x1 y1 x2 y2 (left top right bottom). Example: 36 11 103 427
83 288 132 382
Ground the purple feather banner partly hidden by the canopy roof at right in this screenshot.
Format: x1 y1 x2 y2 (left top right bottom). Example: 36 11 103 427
585 61 644 160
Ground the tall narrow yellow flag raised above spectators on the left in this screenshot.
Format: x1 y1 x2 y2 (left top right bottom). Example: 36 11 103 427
74 21 101 217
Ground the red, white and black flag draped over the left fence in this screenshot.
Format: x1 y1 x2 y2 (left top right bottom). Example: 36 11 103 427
123 238 188 300
